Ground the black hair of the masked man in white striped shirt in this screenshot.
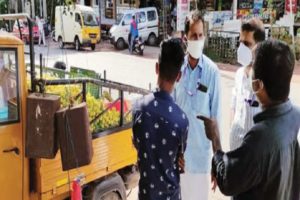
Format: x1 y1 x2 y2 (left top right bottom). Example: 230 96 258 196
242 22 266 43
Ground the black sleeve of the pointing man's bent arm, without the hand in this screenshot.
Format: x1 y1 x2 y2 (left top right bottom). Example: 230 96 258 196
212 138 263 196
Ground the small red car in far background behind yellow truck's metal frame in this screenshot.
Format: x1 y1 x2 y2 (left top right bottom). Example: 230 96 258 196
13 20 40 44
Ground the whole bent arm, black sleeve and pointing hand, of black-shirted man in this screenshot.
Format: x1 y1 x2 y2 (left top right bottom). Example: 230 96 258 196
198 116 262 196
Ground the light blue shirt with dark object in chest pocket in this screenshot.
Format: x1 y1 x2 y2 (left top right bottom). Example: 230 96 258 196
173 55 221 173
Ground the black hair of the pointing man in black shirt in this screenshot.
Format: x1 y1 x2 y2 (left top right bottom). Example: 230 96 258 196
253 40 295 101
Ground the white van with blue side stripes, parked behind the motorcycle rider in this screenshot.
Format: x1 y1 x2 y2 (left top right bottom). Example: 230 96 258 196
109 7 159 49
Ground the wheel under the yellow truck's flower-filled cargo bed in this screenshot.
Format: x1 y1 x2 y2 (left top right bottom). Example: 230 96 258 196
90 174 126 200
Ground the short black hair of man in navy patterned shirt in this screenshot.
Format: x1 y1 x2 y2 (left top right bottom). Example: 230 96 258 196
159 39 185 82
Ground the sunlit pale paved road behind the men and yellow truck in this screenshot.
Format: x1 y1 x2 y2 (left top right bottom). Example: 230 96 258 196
27 39 300 200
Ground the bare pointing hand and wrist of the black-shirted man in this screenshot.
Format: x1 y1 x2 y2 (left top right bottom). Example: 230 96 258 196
197 115 222 152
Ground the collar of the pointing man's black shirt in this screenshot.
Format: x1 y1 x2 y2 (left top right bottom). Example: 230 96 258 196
254 100 293 123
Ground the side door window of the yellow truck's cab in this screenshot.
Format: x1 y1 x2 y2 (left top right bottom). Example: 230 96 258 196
0 48 19 124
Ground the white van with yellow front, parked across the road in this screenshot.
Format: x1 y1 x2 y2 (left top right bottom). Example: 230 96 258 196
55 5 100 50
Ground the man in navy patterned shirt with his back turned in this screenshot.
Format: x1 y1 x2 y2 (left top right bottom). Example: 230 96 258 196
133 39 188 200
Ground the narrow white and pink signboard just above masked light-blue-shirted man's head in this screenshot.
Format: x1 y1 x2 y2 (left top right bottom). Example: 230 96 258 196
177 0 190 31
